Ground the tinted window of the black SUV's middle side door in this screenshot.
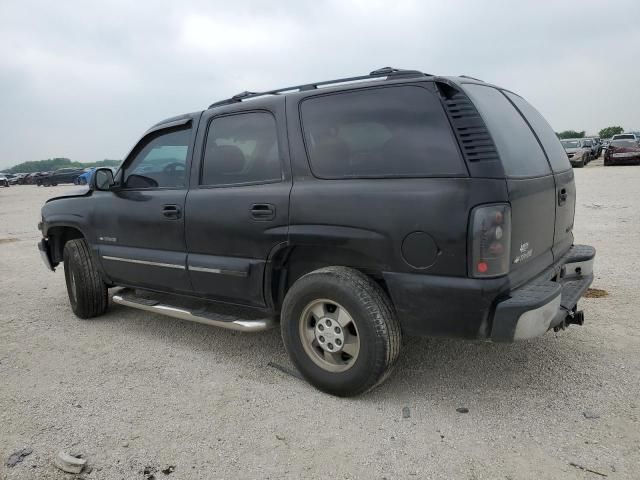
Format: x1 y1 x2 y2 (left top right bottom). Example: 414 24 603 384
200 112 282 185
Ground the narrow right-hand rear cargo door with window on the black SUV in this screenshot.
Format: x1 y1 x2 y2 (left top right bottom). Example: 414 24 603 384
504 92 576 259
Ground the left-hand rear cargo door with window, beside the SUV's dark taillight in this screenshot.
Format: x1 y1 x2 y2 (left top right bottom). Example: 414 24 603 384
463 83 566 284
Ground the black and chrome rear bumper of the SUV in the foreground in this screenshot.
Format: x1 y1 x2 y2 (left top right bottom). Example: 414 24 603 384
491 245 596 342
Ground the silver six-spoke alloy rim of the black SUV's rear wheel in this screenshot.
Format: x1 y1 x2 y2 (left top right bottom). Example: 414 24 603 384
299 299 360 373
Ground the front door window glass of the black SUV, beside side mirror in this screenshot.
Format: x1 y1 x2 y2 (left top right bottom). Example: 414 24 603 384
124 129 191 188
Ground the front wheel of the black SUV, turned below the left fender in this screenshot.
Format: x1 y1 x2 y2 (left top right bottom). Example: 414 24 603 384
63 238 109 319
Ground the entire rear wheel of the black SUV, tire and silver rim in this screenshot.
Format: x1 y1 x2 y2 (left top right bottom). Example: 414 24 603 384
281 267 402 397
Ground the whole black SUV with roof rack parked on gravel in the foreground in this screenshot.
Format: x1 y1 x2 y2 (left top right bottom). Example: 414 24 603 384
39 68 595 396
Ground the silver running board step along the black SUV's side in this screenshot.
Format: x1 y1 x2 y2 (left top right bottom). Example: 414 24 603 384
113 288 276 332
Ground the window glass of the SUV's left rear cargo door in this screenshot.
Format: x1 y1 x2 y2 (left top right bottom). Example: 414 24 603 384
464 84 551 177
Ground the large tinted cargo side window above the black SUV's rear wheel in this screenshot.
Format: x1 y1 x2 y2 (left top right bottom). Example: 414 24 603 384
301 86 466 179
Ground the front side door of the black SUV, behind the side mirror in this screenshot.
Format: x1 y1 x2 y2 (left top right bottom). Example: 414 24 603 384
93 119 197 293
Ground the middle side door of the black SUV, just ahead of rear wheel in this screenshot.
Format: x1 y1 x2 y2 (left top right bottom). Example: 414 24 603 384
185 98 291 306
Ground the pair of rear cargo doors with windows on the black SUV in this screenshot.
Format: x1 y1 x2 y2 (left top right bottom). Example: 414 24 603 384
463 83 575 285
